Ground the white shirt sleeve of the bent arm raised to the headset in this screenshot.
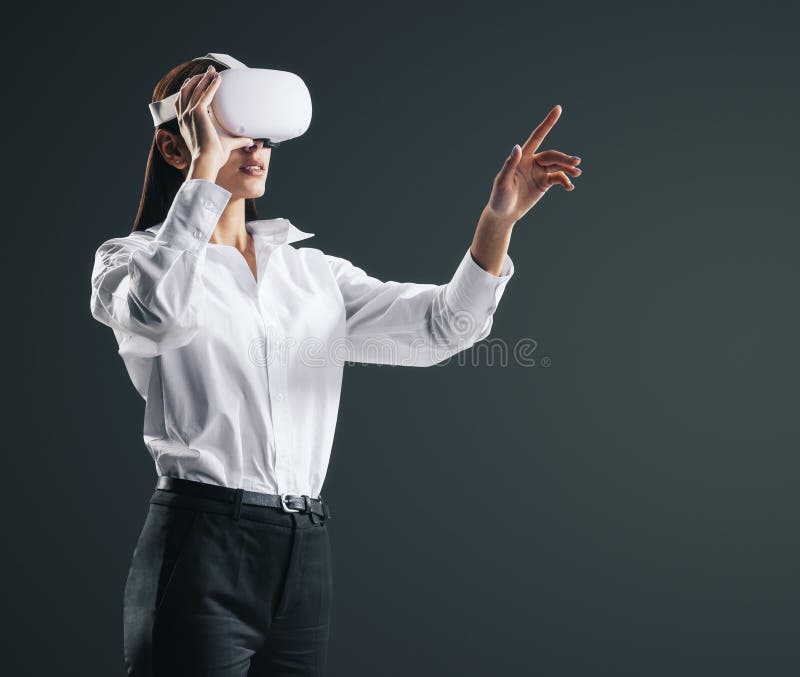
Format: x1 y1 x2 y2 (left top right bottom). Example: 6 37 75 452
90 179 231 357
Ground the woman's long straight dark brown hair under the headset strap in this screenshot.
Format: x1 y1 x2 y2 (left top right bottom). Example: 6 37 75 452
131 58 258 232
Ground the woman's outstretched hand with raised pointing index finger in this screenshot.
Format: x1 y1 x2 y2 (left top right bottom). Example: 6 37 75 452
484 106 581 222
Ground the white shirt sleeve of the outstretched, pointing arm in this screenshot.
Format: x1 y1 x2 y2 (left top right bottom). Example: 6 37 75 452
325 249 514 367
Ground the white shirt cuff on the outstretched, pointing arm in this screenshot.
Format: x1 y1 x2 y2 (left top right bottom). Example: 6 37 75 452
445 248 514 325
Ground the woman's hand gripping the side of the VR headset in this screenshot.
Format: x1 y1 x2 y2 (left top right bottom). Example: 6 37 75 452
175 66 253 171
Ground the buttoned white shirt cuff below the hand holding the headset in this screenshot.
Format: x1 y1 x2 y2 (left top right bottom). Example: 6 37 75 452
156 179 232 253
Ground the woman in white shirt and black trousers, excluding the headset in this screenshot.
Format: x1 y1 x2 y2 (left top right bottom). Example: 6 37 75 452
91 58 580 677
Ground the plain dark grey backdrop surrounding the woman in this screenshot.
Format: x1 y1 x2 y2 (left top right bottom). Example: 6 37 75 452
3 2 800 677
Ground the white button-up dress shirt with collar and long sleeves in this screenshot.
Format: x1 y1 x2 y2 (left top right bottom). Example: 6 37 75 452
90 179 514 498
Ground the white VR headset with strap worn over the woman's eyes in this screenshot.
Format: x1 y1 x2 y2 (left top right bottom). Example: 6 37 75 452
149 52 311 148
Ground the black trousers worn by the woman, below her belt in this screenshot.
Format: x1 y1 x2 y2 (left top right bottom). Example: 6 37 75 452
123 478 332 677
